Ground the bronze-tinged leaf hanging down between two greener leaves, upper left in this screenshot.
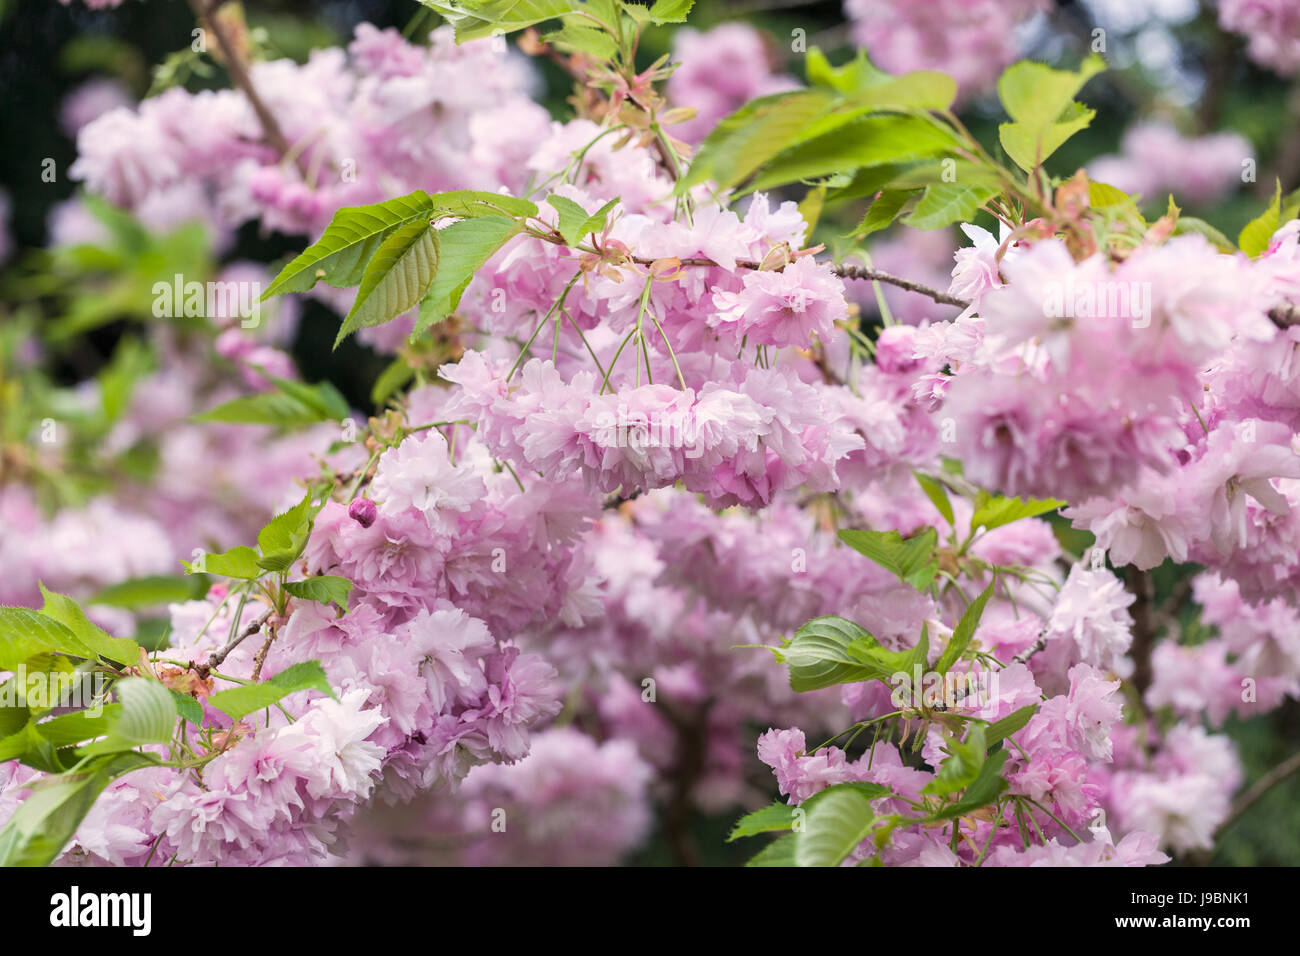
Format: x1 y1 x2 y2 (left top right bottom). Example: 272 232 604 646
334 220 441 349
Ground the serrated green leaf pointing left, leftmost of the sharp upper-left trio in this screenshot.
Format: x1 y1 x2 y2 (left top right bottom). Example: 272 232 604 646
261 190 433 300
